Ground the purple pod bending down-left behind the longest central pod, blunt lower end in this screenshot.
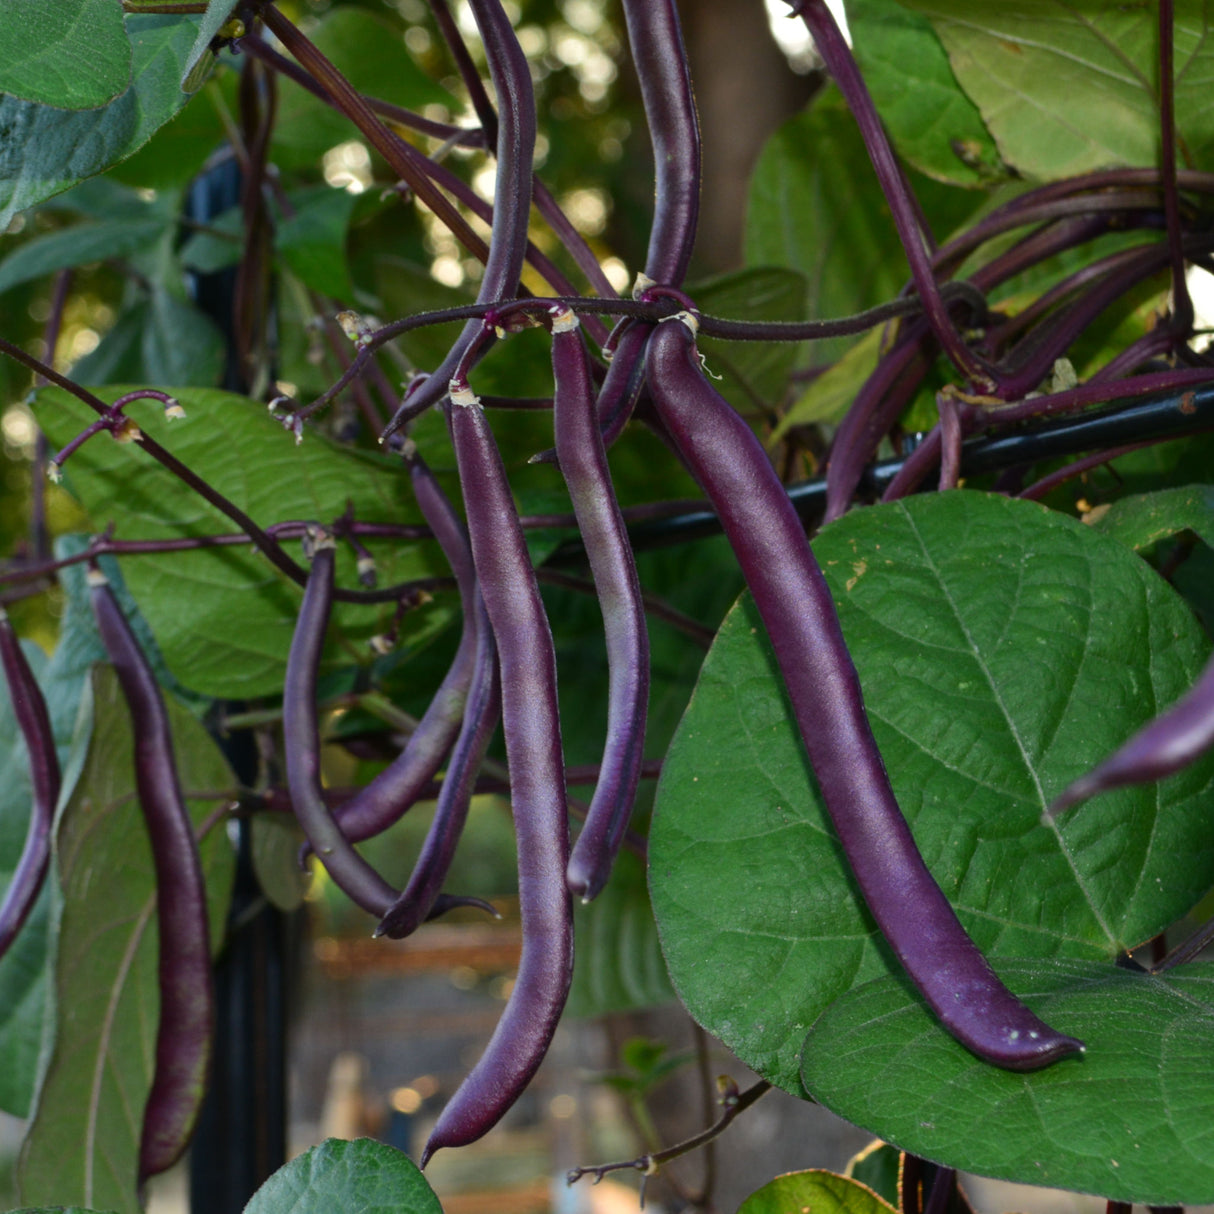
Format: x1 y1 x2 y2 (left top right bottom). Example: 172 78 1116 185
333 439 480 843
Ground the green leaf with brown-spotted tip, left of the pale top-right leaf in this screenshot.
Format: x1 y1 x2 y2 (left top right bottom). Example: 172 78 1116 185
847 0 1008 186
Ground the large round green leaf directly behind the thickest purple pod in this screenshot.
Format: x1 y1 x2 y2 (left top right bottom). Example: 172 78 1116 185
649 492 1214 1093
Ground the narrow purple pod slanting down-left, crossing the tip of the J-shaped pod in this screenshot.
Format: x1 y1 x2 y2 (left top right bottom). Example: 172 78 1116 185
375 594 501 940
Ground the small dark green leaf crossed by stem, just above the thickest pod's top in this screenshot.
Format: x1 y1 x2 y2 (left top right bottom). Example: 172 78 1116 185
691 267 806 413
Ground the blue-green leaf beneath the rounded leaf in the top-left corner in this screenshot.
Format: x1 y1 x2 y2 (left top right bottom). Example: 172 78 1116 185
0 16 195 228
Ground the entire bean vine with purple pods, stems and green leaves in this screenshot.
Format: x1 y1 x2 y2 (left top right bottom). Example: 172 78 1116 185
0 0 1214 1214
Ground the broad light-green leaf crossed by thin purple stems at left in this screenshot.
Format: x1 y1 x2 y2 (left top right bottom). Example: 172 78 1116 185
36 388 449 698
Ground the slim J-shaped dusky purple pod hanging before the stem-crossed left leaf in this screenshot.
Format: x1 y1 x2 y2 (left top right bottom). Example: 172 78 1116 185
283 528 397 915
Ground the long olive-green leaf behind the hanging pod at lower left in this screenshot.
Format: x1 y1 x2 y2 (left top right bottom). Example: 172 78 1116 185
19 666 236 1214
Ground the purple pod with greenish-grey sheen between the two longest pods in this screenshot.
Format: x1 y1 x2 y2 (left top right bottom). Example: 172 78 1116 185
552 307 649 902
